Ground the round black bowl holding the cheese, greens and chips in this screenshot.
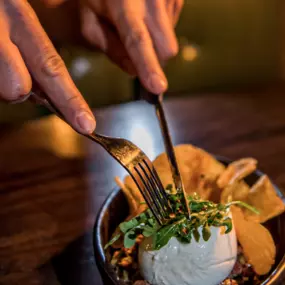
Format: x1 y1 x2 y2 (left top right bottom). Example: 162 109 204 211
93 158 285 285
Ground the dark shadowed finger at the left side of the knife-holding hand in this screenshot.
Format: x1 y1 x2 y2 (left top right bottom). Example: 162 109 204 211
81 6 137 76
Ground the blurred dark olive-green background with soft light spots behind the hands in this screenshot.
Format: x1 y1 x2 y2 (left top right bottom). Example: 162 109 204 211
0 0 285 123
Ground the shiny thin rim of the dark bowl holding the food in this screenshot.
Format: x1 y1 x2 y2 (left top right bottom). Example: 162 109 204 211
93 155 285 285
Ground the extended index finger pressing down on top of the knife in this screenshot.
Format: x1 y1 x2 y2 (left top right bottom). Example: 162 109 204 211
109 0 167 94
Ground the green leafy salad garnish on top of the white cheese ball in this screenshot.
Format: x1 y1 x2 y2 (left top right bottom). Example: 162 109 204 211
105 183 258 250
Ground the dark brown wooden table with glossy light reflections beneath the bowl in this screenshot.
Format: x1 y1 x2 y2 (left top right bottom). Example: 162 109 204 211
0 89 285 285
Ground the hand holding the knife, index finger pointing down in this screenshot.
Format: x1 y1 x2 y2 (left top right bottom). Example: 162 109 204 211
79 0 183 94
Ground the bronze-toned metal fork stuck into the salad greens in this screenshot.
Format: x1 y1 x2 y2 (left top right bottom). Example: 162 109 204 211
30 90 172 225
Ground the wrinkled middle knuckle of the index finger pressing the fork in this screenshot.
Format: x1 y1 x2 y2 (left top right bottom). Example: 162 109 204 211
41 48 65 77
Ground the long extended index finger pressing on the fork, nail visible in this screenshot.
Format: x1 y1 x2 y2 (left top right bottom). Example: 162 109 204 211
9 1 95 133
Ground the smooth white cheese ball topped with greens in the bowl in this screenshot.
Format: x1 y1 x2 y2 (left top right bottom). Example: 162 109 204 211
139 222 237 285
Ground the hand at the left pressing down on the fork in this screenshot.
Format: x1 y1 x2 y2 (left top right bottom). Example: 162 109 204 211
0 0 95 133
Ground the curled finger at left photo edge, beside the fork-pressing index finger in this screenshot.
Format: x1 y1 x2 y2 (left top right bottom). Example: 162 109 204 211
0 17 32 102
